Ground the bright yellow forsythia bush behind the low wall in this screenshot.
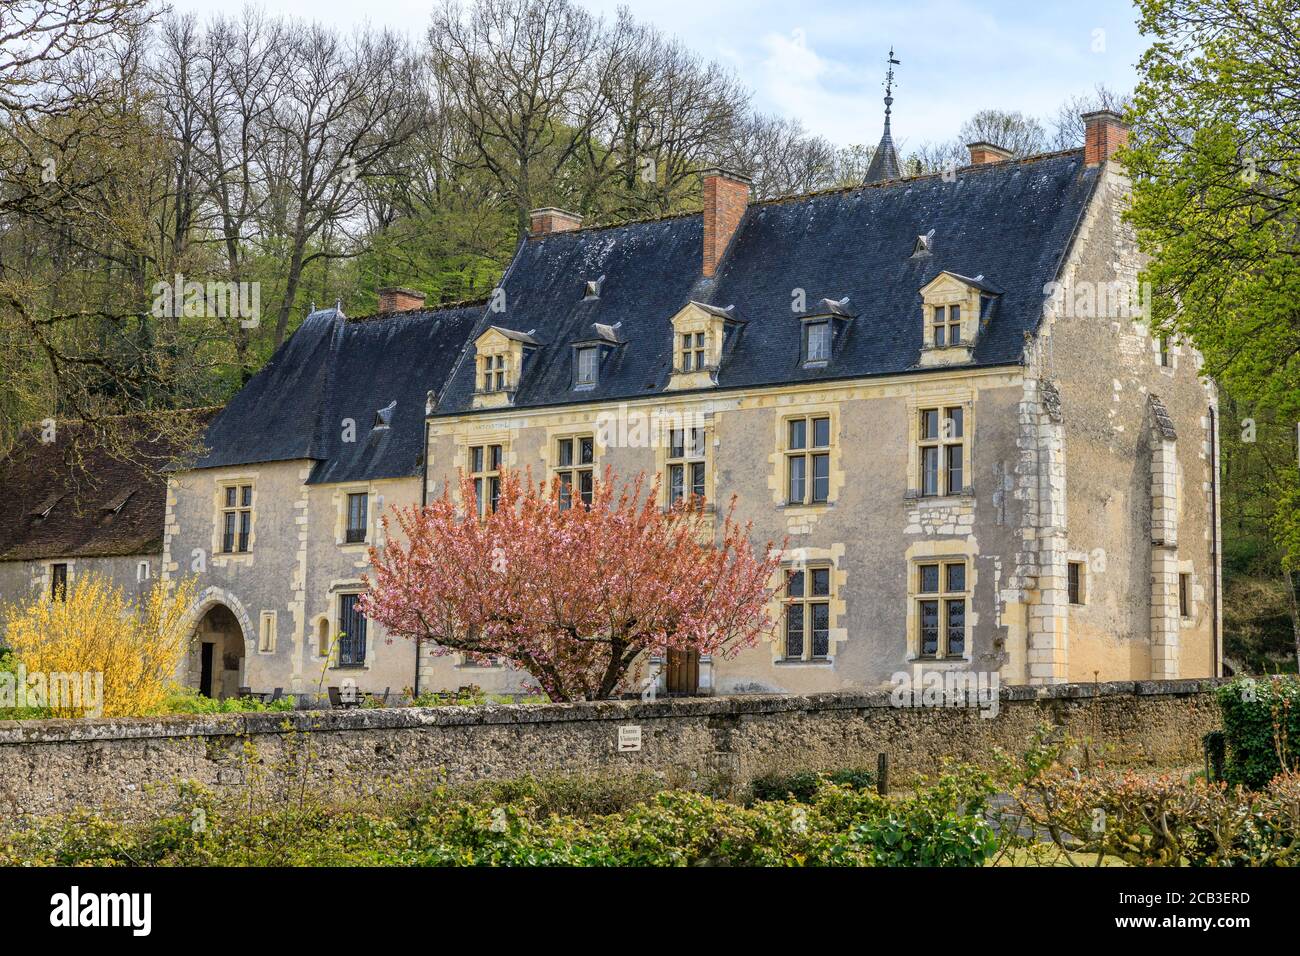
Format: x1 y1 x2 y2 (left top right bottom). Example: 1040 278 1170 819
0 574 195 717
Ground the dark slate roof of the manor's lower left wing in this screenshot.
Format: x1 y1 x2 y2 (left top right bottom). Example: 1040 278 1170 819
195 303 484 484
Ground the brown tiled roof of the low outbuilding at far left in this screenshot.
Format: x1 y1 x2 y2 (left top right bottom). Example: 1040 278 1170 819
0 408 216 561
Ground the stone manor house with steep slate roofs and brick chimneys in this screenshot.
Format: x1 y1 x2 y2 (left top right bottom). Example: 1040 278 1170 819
0 112 1222 695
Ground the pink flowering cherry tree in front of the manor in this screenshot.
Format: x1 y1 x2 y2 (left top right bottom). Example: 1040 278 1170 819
361 470 780 701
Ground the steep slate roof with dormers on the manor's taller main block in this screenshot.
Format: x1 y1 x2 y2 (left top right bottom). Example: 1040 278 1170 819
434 150 1099 415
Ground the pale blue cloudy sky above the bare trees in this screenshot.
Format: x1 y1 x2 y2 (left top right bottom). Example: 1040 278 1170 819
172 0 1145 147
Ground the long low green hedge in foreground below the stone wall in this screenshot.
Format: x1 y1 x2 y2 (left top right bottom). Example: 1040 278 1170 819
0 778 997 866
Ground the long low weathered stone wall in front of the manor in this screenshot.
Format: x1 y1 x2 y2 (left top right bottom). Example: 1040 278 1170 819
0 680 1218 816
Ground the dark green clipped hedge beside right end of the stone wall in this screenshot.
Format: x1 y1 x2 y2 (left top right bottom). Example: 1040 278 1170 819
1217 675 1300 790
